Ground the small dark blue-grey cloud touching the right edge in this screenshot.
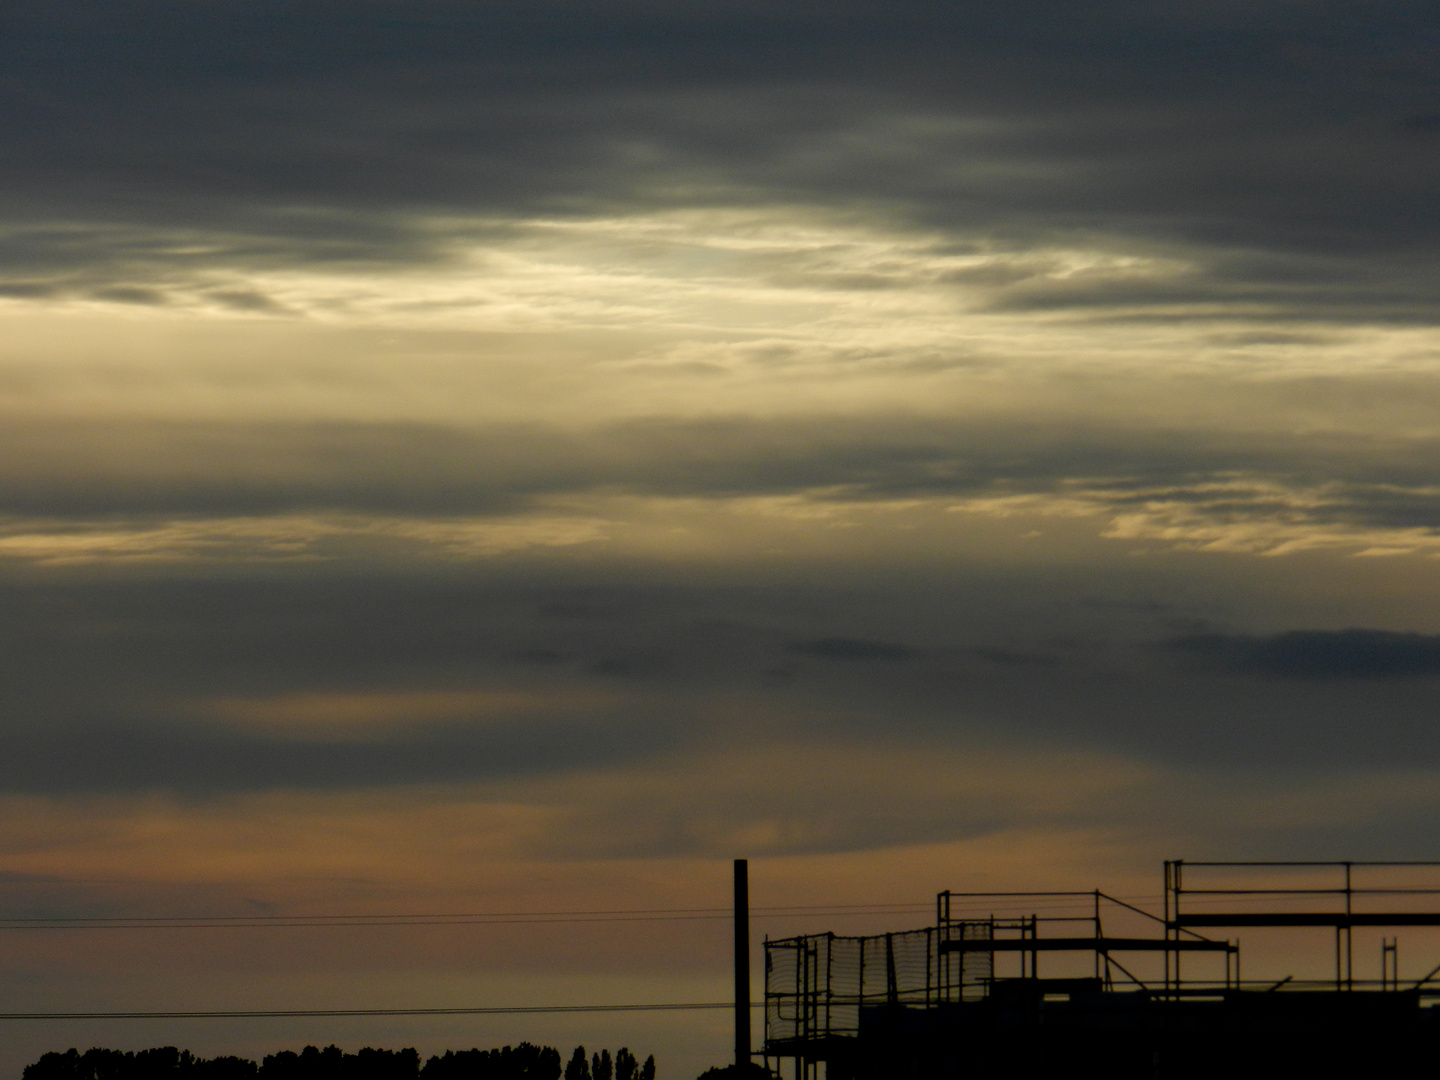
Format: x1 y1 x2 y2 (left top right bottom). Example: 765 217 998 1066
1171 629 1440 680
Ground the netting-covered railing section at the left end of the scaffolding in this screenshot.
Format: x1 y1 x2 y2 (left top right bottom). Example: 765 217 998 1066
765 922 994 1044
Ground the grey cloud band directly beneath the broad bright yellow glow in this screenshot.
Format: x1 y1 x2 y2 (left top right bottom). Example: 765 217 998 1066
0 417 1440 550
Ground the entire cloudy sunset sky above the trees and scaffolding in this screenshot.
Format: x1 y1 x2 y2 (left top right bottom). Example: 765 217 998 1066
0 0 1440 1080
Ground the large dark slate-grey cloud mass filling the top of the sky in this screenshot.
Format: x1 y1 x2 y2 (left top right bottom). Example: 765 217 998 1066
0 0 1440 323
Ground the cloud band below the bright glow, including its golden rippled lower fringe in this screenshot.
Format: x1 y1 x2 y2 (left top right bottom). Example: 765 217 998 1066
0 415 1440 566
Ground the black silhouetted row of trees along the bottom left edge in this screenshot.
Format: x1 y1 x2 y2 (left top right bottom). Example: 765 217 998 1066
23 1043 655 1080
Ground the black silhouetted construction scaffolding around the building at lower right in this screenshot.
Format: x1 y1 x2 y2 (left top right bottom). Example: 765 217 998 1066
763 860 1440 1080
